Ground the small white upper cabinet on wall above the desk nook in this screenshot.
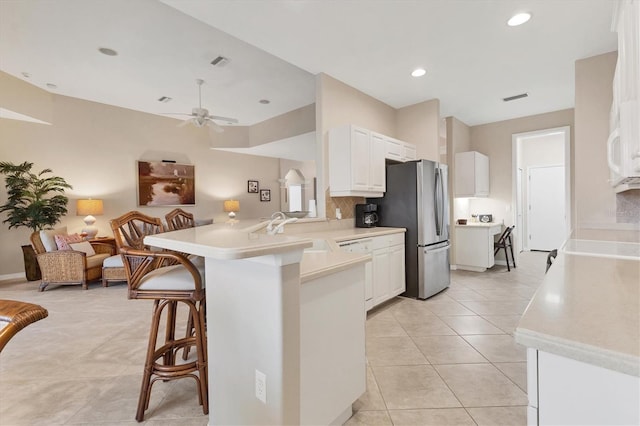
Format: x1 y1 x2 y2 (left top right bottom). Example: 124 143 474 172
454 151 489 197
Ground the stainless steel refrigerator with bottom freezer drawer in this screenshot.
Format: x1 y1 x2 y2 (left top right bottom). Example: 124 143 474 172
367 160 450 299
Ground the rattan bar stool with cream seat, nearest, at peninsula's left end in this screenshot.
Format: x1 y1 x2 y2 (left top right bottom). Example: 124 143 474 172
111 212 209 422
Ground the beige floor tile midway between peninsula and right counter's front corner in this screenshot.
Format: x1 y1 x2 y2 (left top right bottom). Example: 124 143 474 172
413 336 488 364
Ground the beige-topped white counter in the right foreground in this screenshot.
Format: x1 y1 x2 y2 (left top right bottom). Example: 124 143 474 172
515 229 640 425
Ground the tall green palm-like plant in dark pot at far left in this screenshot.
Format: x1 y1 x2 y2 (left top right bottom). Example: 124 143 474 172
0 161 73 281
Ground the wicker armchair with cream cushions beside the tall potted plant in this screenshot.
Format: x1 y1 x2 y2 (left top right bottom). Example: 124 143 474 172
31 232 115 291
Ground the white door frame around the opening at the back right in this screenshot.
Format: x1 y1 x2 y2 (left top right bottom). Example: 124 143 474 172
511 126 573 260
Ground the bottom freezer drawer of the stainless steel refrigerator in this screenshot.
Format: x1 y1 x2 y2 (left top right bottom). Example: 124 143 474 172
418 242 451 299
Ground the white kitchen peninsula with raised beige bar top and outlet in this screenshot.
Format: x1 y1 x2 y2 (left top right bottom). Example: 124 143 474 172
145 225 370 424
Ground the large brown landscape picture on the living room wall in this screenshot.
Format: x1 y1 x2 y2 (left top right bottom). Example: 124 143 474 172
138 161 196 206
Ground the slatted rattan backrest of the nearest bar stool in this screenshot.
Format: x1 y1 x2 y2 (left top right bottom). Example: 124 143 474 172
111 211 163 250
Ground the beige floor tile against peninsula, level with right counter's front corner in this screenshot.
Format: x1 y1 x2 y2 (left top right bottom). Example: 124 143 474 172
366 337 429 366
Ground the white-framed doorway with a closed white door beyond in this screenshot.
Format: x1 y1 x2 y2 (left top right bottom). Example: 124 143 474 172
512 126 571 257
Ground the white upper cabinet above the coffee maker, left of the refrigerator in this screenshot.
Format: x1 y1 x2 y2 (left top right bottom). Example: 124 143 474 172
329 125 385 197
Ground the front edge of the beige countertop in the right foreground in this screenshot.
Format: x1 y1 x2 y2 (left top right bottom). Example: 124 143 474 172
514 327 640 377
